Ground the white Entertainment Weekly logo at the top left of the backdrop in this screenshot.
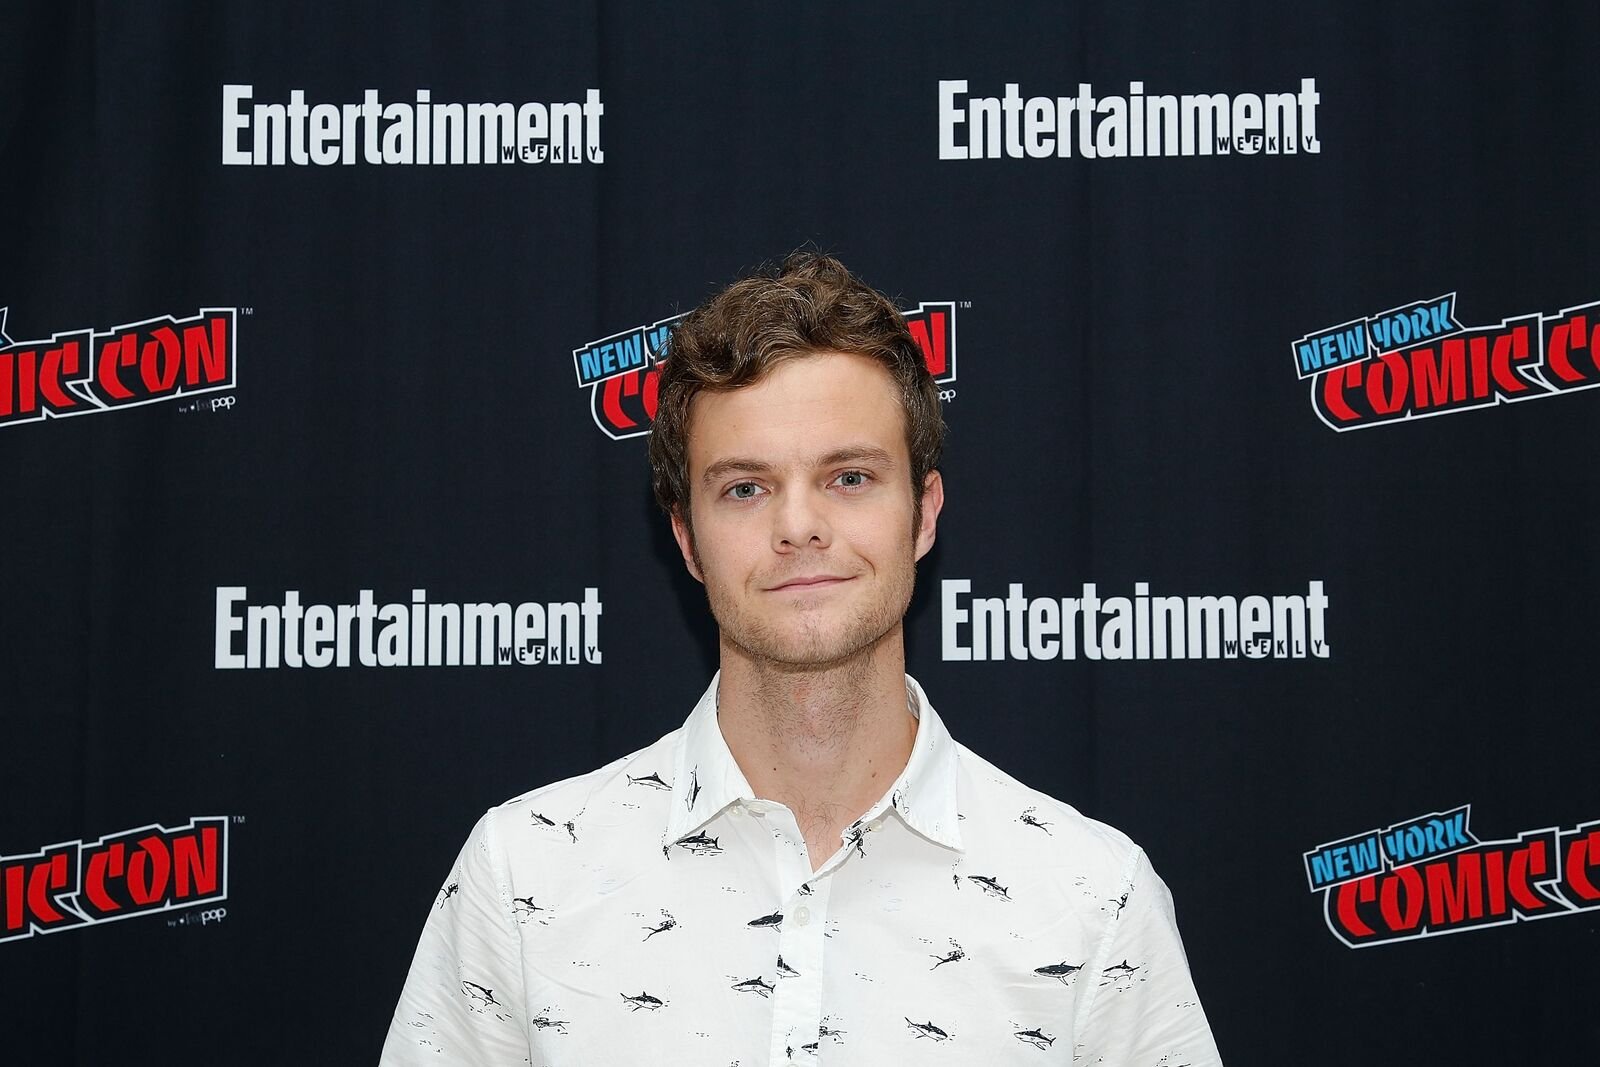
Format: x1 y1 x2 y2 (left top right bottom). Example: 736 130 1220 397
222 85 605 166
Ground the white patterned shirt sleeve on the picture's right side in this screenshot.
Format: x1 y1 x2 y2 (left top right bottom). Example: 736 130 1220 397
1072 849 1222 1067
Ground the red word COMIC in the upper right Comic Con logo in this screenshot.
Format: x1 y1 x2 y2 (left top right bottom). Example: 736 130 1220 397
1312 315 1550 430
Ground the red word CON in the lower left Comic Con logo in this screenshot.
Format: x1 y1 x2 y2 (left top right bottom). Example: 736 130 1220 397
82 819 227 920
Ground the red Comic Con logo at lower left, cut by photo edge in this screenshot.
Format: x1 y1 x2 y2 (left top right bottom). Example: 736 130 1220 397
0 817 229 941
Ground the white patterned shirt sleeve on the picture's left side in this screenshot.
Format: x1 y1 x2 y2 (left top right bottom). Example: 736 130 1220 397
379 811 528 1067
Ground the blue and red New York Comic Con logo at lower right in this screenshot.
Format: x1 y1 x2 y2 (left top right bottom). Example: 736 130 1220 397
1304 805 1600 949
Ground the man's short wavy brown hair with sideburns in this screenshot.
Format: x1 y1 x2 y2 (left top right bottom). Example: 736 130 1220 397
650 250 944 536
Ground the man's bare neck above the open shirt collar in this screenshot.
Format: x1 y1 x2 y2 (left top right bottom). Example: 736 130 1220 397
717 627 917 869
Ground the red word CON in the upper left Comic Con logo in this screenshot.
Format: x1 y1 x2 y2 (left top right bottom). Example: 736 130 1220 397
90 309 234 408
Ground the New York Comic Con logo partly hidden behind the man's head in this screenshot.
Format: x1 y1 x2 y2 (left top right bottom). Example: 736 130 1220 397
573 301 955 442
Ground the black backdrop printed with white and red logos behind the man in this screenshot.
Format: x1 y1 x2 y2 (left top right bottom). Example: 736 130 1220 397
0 2 1600 1067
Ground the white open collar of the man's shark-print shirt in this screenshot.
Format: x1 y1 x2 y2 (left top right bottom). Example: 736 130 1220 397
662 670 962 851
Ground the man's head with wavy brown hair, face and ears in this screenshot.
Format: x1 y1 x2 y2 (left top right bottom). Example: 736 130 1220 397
650 253 944 664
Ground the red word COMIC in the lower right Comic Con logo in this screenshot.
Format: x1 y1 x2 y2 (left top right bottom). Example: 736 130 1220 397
1323 830 1561 947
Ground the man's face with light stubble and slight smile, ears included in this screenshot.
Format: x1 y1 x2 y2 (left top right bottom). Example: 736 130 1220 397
672 352 944 667
